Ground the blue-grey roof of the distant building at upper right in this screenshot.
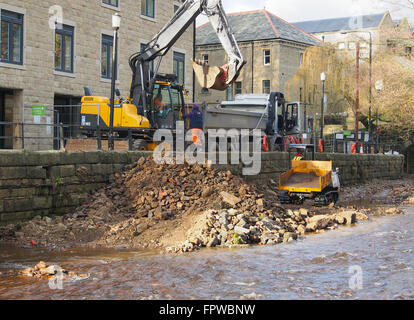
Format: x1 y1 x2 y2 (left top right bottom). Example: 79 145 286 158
293 13 386 33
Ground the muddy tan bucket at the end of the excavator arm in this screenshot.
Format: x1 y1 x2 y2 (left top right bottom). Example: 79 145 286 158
192 60 229 91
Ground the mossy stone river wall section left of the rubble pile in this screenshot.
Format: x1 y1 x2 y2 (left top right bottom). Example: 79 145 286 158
0 151 151 224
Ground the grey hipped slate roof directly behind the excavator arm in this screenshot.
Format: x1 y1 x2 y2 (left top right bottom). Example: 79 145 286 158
196 10 320 46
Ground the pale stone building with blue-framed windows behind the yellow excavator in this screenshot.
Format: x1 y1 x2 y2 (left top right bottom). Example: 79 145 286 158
0 0 195 150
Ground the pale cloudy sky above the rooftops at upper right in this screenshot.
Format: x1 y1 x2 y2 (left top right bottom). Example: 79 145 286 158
197 0 414 25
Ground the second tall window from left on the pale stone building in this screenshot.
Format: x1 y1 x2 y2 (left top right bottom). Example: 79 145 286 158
55 25 75 72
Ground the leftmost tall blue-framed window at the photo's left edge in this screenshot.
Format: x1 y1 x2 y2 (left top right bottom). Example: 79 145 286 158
0 10 23 64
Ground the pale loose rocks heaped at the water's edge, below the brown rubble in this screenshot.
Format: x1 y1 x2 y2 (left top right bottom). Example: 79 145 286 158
167 208 372 253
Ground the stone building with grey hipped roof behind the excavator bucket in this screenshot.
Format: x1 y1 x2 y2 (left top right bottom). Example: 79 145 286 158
195 10 321 104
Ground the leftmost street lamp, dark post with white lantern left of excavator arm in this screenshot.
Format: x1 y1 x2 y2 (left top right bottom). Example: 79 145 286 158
108 13 121 151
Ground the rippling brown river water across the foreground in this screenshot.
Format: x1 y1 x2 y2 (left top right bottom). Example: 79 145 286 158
0 207 414 300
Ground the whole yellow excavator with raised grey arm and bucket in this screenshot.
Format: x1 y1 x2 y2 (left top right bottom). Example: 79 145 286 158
80 0 246 150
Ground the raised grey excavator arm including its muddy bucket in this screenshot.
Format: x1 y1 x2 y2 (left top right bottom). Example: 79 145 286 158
129 0 246 113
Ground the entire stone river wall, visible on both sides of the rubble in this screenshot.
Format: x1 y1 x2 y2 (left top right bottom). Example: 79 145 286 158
0 151 404 224
